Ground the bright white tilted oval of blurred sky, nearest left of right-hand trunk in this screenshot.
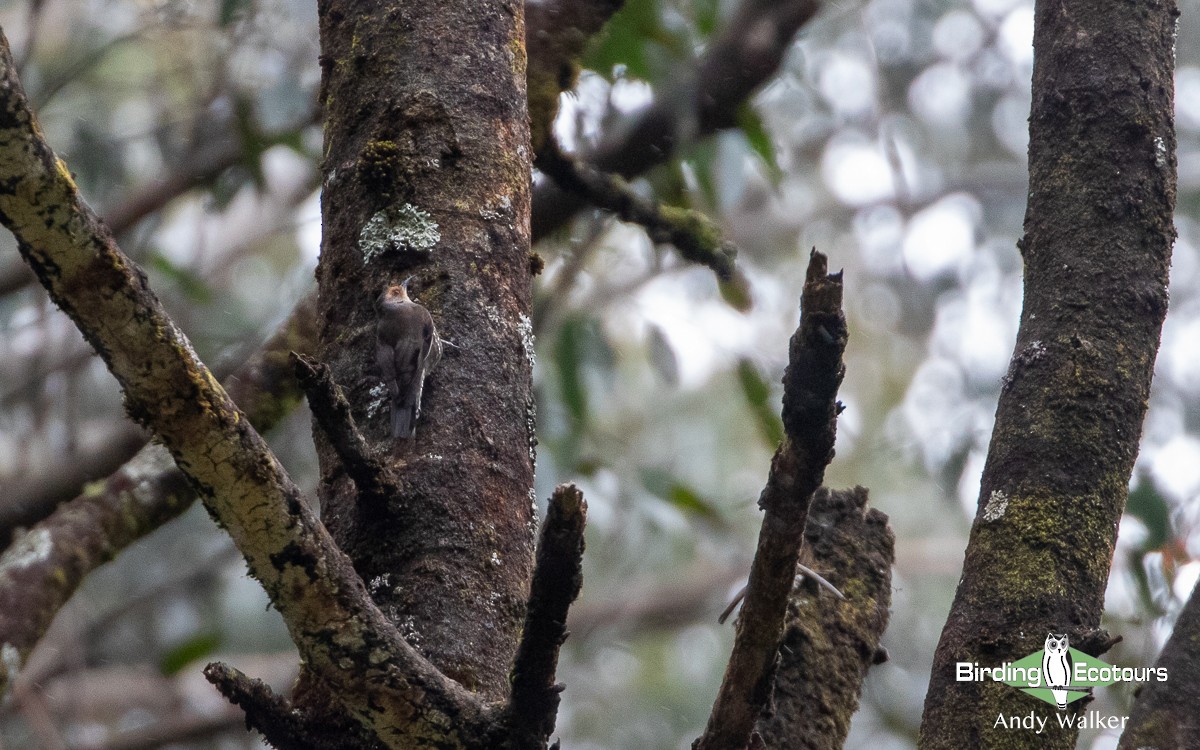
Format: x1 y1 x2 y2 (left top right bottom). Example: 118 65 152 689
904 193 982 281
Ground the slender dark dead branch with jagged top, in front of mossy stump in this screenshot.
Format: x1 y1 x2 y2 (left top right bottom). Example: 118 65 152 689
692 250 847 750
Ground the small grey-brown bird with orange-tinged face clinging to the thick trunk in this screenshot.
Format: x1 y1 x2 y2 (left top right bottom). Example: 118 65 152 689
376 276 442 438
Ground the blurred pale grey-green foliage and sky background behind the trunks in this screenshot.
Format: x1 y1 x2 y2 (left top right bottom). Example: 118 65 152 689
0 0 1200 750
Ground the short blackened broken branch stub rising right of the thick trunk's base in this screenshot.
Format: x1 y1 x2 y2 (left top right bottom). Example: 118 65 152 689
506 485 588 750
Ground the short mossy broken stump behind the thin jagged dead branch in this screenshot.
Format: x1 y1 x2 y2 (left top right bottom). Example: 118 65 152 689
757 487 895 750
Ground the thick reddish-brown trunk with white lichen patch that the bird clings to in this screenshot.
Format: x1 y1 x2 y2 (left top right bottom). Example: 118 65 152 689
312 0 535 707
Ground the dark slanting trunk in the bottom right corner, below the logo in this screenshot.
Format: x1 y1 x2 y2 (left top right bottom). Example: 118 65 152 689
1117 578 1200 750
